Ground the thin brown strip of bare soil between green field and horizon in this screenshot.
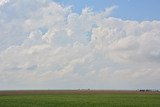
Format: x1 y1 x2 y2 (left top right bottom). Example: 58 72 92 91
0 90 160 95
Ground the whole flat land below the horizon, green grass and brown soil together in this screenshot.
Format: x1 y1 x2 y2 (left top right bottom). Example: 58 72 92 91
0 90 160 107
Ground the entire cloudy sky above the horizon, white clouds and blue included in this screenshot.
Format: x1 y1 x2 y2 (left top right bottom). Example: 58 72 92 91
0 0 160 90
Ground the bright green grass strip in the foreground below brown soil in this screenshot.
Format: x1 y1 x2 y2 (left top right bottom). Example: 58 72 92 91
0 94 160 107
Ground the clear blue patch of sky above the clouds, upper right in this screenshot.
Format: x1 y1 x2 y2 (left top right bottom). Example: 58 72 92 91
55 0 160 21
